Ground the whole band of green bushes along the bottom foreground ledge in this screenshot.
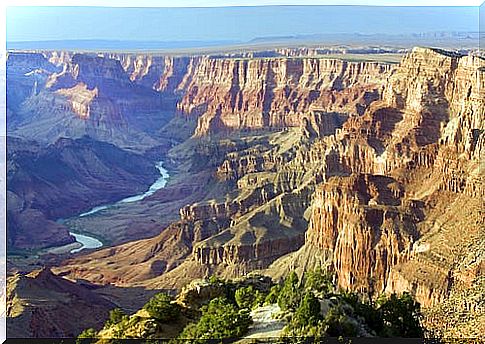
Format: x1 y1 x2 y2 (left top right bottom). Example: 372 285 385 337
78 269 423 343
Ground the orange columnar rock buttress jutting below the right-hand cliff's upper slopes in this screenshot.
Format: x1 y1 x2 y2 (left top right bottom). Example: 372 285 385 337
307 174 419 292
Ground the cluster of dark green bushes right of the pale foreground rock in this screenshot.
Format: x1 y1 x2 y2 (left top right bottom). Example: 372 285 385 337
278 270 423 338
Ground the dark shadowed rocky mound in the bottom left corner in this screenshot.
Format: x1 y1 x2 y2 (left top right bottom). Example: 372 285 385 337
6 269 115 338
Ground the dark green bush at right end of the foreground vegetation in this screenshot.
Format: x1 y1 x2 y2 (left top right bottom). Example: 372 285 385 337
378 293 424 338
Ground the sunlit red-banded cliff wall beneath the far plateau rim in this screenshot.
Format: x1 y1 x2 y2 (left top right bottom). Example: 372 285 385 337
177 58 392 136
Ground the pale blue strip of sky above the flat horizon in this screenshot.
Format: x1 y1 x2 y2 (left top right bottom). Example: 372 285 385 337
6 4 478 42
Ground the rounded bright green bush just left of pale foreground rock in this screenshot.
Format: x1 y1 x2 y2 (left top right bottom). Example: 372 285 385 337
179 297 251 343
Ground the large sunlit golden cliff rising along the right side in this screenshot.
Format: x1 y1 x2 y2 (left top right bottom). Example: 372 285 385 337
272 48 485 320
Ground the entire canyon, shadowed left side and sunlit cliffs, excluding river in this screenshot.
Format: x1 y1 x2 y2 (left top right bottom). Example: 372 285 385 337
7 47 485 338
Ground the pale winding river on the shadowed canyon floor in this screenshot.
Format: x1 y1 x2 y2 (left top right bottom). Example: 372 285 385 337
69 161 169 253
